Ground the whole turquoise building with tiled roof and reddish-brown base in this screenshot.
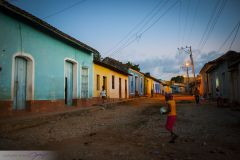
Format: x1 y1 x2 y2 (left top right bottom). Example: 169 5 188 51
0 1 98 113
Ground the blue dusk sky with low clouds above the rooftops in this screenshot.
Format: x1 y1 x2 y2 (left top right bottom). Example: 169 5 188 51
9 0 240 80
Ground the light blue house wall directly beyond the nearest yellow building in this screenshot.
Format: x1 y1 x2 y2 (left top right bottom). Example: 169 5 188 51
128 69 144 96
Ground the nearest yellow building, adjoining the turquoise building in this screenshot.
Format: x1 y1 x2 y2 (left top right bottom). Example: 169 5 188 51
93 61 128 98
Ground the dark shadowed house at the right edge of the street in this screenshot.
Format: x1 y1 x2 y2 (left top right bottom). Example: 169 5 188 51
200 51 240 102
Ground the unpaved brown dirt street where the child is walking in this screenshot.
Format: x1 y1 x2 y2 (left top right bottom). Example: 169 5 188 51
0 98 240 160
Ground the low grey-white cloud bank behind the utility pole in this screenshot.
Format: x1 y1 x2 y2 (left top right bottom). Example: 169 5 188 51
134 50 222 80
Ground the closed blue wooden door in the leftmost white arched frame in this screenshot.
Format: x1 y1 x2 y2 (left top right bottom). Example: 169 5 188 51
13 57 27 110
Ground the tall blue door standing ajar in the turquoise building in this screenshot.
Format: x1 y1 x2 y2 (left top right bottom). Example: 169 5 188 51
65 61 73 106
